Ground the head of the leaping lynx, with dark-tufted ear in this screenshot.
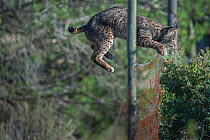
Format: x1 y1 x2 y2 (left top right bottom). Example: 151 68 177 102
158 23 178 46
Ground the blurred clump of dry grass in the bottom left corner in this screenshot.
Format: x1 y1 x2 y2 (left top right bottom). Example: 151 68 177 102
0 99 75 140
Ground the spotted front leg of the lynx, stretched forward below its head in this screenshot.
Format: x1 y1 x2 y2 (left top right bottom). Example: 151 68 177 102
137 38 167 55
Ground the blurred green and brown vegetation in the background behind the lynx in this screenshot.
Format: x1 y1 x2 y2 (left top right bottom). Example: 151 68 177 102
0 0 210 140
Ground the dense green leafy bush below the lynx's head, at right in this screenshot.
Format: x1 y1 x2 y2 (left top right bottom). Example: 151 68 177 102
159 49 210 139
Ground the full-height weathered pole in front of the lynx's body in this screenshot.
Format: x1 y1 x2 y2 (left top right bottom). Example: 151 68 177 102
127 0 137 140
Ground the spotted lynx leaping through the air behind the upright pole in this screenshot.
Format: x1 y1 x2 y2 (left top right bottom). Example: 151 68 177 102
68 7 178 72
